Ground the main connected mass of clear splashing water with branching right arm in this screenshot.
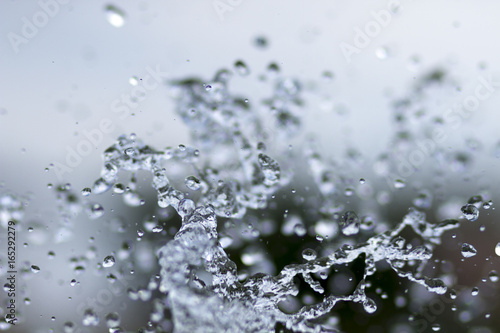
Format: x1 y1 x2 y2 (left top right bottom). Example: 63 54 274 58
74 66 477 332
